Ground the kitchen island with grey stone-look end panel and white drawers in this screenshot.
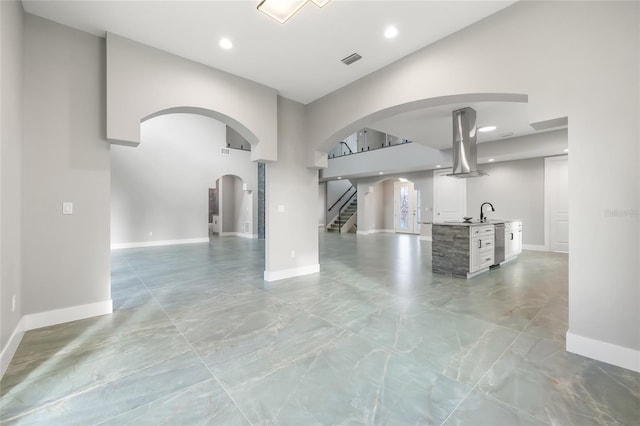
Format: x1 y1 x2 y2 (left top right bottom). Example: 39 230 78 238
431 220 522 278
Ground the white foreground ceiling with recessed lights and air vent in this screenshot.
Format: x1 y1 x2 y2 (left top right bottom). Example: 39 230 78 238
23 0 515 105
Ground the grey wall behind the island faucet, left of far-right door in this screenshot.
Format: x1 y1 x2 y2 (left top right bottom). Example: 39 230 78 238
467 158 545 248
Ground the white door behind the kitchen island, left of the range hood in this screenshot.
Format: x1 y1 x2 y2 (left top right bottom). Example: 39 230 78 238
433 169 467 223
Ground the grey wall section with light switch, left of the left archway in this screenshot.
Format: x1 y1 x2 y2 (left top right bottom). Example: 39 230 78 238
22 14 111 312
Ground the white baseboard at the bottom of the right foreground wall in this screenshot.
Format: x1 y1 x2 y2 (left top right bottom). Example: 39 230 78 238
567 331 640 373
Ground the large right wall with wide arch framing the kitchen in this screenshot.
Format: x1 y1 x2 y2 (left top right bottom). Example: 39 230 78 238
307 2 640 370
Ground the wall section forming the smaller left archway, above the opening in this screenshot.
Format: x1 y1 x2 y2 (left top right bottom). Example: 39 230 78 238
106 34 278 161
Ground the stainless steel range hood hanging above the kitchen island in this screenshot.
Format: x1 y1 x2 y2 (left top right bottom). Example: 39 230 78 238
447 107 487 178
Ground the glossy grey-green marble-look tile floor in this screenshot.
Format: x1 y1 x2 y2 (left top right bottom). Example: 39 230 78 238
0 233 640 426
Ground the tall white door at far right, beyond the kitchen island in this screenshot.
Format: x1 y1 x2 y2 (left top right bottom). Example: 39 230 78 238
544 155 569 253
